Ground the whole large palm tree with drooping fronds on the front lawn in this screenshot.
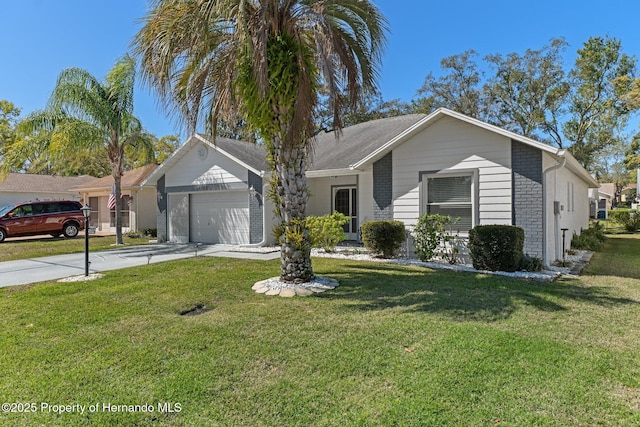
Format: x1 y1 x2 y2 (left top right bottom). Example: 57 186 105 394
134 0 386 288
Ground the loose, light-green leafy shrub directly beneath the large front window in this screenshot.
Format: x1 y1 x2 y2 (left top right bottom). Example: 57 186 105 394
412 214 460 264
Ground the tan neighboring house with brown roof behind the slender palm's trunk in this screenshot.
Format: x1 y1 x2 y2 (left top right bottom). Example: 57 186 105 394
73 164 158 232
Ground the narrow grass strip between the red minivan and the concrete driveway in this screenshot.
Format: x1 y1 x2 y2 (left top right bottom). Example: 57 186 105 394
0 236 149 262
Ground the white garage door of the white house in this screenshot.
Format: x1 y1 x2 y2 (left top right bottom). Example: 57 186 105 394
189 190 249 244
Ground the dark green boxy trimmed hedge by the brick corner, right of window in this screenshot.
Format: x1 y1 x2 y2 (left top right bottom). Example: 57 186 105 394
469 225 524 271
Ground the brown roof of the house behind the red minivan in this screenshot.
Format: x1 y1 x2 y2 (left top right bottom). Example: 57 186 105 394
0 173 96 193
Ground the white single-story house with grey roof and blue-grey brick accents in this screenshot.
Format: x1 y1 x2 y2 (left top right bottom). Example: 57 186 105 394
144 109 598 264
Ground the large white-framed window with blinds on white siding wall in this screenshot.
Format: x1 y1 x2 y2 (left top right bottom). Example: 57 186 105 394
425 174 473 232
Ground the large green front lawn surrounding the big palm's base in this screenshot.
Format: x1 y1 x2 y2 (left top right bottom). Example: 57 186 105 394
0 236 640 426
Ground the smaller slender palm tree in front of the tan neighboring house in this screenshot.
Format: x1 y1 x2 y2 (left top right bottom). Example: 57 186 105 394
20 55 153 244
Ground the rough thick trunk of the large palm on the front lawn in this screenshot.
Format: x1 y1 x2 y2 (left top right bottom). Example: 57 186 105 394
272 141 315 283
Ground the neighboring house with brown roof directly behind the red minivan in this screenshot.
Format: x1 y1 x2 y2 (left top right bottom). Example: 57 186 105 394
0 173 95 207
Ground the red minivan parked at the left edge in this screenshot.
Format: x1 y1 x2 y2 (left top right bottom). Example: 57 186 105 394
0 200 84 242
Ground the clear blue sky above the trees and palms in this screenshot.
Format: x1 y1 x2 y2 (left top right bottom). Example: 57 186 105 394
0 0 640 140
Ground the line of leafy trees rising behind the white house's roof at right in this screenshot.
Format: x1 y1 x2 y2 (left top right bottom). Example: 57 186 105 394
318 37 640 182
